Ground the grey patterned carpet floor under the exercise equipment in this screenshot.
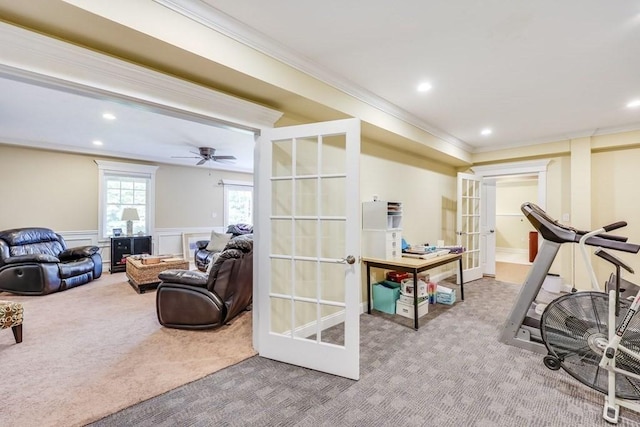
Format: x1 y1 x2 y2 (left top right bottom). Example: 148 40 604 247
92 278 640 427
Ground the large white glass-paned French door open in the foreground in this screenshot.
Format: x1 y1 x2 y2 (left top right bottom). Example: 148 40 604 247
254 119 362 379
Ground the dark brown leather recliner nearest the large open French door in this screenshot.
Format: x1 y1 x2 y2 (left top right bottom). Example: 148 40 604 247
156 239 253 329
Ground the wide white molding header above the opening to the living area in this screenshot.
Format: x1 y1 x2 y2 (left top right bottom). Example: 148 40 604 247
0 22 282 134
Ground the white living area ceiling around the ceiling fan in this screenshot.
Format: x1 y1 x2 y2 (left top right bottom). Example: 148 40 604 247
0 78 254 171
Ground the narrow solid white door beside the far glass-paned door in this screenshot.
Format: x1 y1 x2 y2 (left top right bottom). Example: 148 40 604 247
480 178 496 276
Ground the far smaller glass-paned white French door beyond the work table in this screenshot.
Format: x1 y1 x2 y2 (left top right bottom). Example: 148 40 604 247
456 173 482 283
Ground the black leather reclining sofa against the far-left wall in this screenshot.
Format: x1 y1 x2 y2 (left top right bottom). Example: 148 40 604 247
0 227 102 295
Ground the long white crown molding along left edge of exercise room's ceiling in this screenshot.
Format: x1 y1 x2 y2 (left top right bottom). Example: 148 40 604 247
153 0 473 152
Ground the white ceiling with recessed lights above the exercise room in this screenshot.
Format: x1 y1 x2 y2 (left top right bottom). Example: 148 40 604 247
203 0 640 151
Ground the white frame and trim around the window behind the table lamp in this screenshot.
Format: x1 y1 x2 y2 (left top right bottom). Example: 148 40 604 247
95 160 158 242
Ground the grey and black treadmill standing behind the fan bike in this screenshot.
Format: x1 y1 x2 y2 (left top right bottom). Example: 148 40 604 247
499 202 640 354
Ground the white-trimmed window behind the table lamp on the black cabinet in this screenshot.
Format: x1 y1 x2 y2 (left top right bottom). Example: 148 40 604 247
95 160 158 240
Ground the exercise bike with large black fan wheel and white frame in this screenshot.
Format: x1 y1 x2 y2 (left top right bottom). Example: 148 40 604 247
540 223 640 424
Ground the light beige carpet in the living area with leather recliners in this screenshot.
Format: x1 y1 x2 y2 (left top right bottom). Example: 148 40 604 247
0 273 255 427
